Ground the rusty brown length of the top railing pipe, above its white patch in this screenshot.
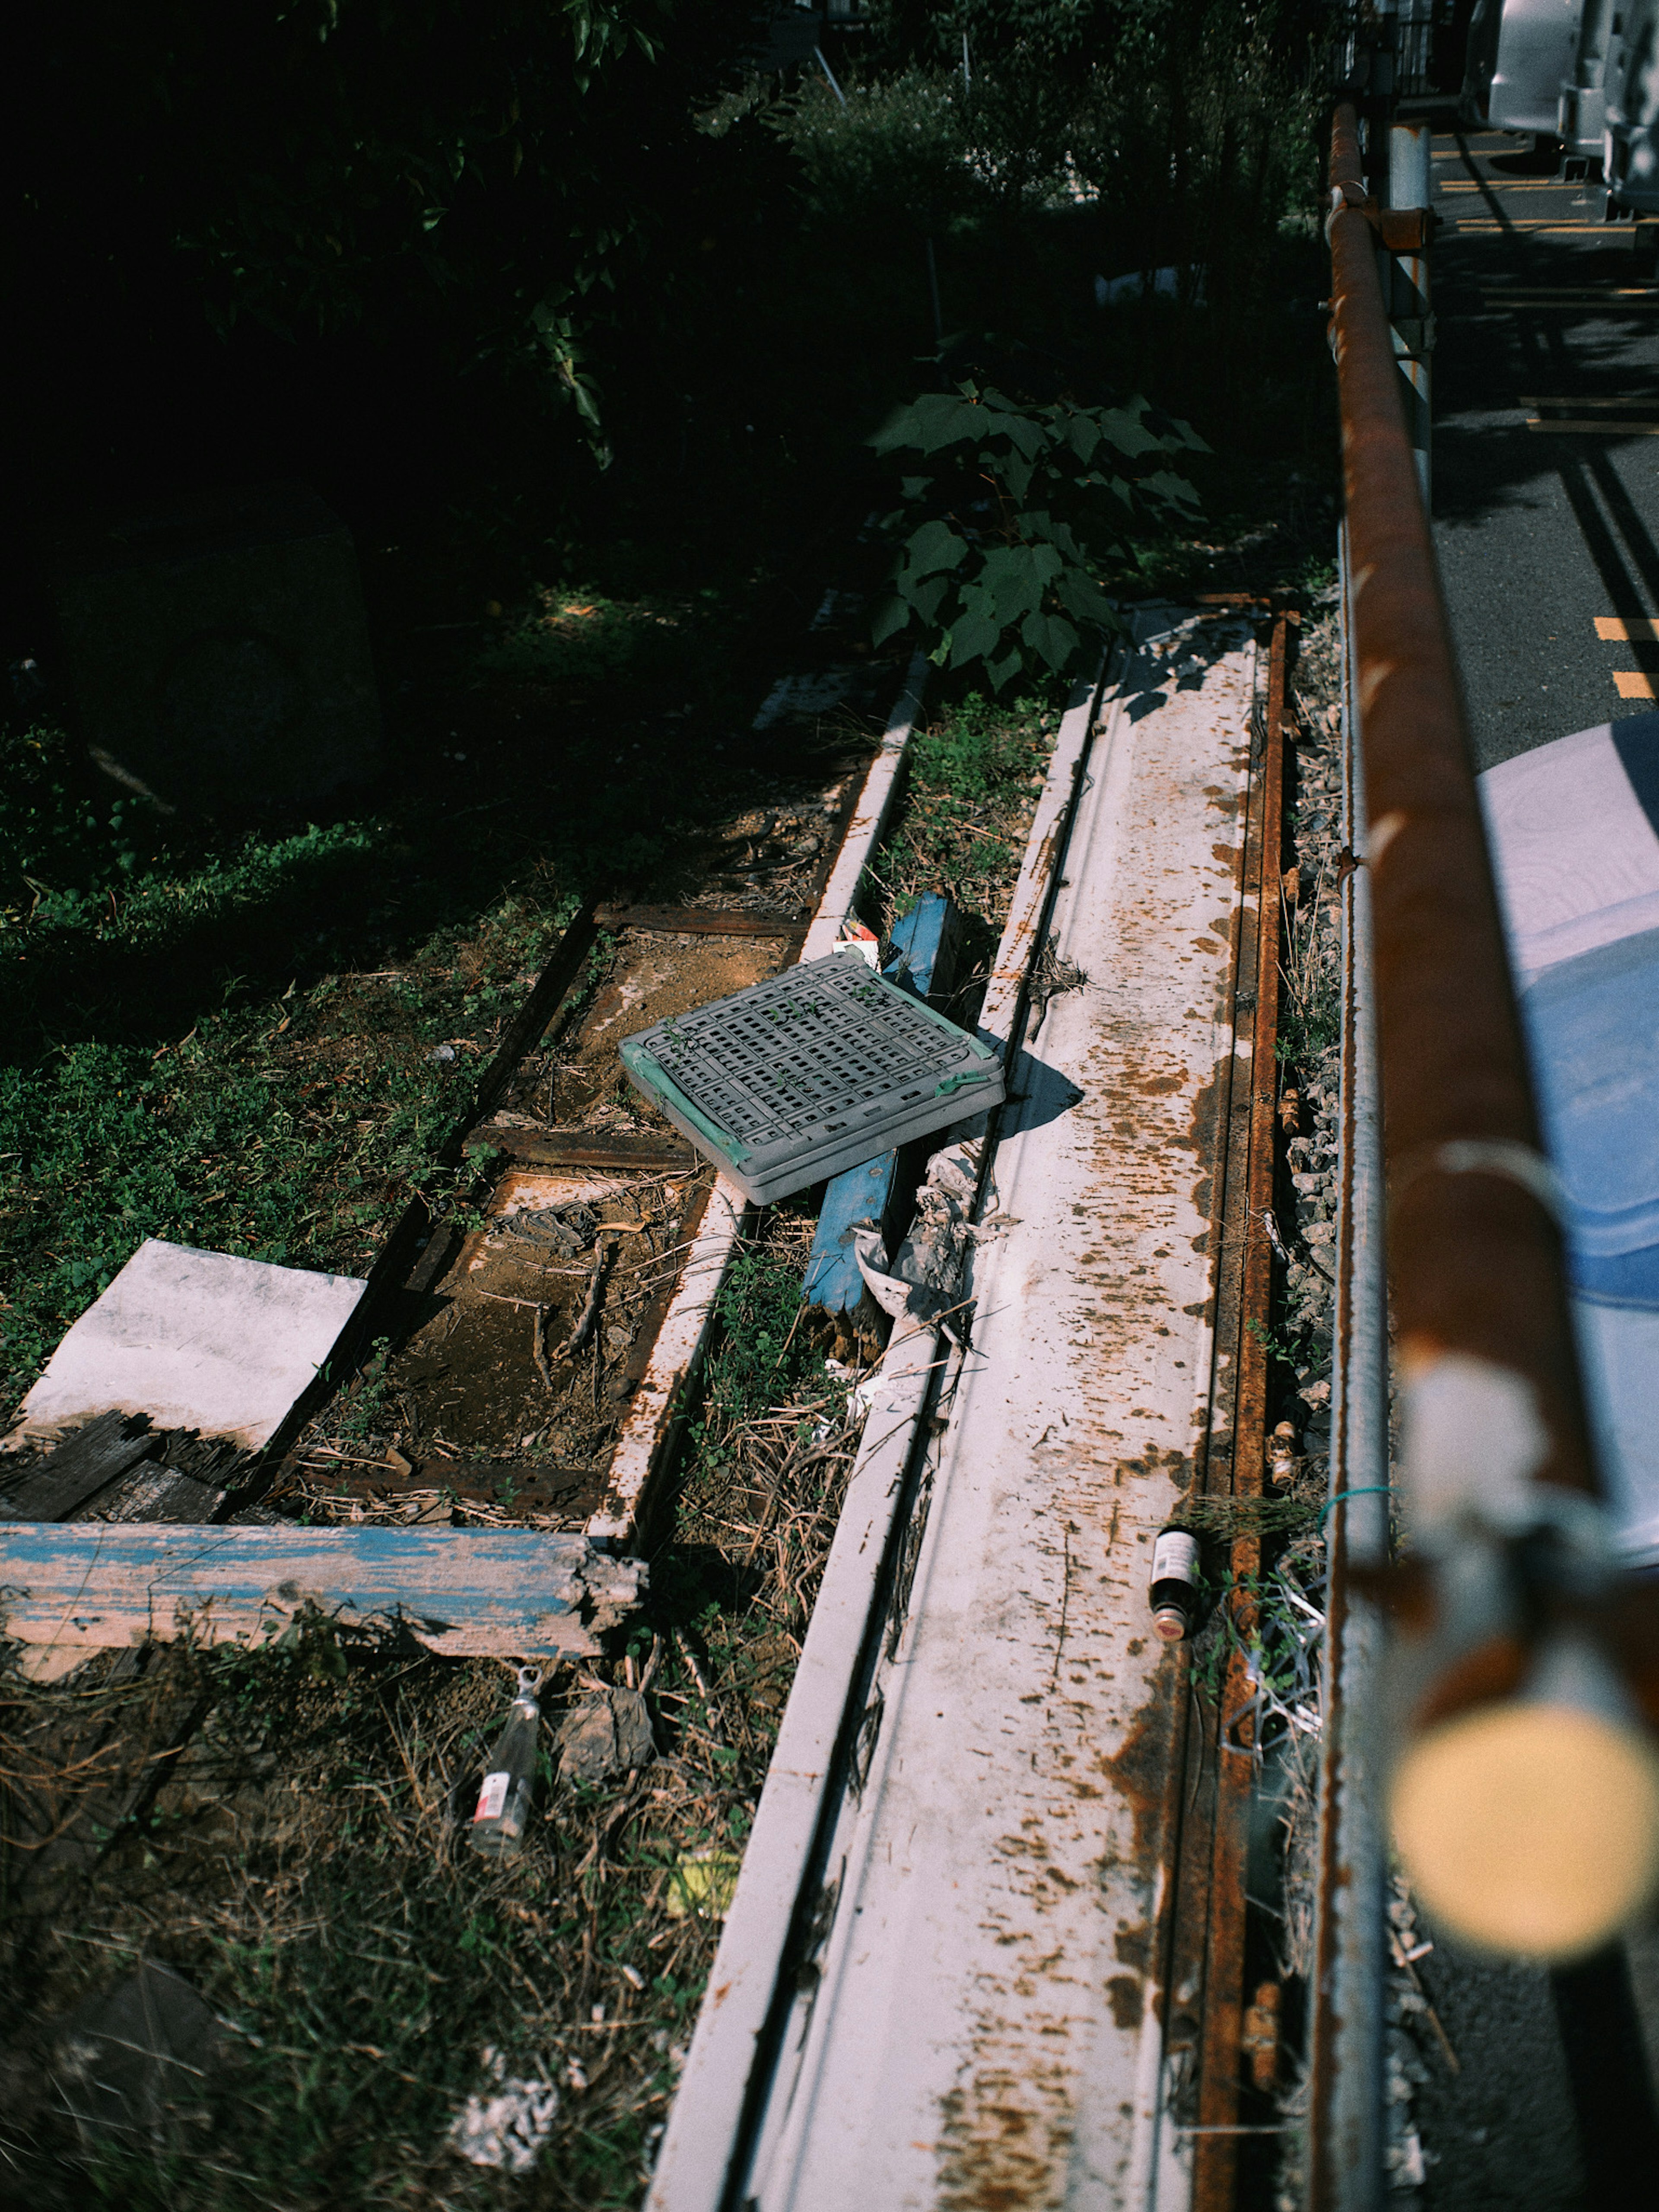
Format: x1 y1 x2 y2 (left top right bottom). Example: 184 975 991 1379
1327 106 1599 1522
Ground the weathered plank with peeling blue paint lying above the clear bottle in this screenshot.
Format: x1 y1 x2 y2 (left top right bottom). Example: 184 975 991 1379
0 1522 646 1657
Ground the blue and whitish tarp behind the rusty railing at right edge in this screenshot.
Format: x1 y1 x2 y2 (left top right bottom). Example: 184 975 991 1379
1480 715 1659 1562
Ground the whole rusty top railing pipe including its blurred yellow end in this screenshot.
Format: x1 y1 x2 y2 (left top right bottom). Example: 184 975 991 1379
1309 104 1659 2206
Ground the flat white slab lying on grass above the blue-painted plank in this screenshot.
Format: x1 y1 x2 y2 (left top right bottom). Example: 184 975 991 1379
6 1236 363 1449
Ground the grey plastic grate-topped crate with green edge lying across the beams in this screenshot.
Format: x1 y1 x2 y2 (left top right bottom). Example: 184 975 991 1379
622 953 1002 1205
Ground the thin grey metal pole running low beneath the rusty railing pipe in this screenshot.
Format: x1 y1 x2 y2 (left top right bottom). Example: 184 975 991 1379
1307 529 1389 2212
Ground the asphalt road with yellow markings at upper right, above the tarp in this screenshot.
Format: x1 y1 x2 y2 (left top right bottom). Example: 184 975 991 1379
1431 133 1659 768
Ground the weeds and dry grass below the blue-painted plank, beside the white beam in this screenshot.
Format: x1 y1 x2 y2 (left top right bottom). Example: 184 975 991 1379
0 1205 858 2212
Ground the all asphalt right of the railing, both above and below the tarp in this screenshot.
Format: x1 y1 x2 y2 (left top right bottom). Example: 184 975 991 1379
1414 130 1659 2212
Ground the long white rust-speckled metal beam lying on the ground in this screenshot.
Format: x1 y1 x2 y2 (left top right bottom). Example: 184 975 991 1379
648 610 1254 2212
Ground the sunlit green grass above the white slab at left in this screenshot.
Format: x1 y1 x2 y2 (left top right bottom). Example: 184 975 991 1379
0 830 571 1405
